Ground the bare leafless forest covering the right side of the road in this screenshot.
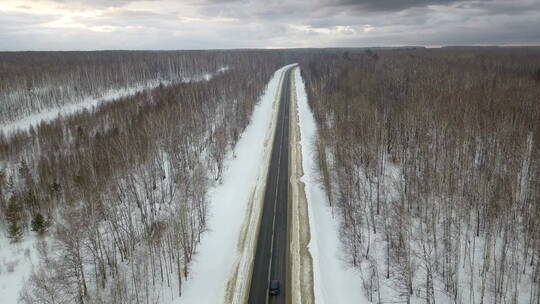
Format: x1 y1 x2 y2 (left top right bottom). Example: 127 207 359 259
301 48 540 304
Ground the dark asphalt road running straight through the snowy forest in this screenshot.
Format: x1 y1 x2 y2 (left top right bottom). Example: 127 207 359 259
249 68 292 304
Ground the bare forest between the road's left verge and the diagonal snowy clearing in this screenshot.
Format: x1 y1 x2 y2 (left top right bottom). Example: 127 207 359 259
0 51 292 304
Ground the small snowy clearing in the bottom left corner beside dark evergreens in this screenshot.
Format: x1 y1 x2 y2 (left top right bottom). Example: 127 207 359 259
0 233 39 304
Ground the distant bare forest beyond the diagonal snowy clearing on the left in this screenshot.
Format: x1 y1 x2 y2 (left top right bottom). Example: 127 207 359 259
0 51 274 123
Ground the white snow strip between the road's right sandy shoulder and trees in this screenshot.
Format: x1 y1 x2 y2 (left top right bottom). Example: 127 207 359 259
294 68 369 304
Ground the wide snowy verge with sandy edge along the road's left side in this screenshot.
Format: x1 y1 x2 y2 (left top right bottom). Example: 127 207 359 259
180 66 296 304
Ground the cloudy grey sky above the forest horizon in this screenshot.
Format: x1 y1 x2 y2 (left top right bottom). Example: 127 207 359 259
0 0 540 51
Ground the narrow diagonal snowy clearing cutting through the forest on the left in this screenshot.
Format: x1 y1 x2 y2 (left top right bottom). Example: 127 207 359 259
0 67 229 134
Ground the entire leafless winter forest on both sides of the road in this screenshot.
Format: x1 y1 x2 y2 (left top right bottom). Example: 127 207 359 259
0 47 540 304
